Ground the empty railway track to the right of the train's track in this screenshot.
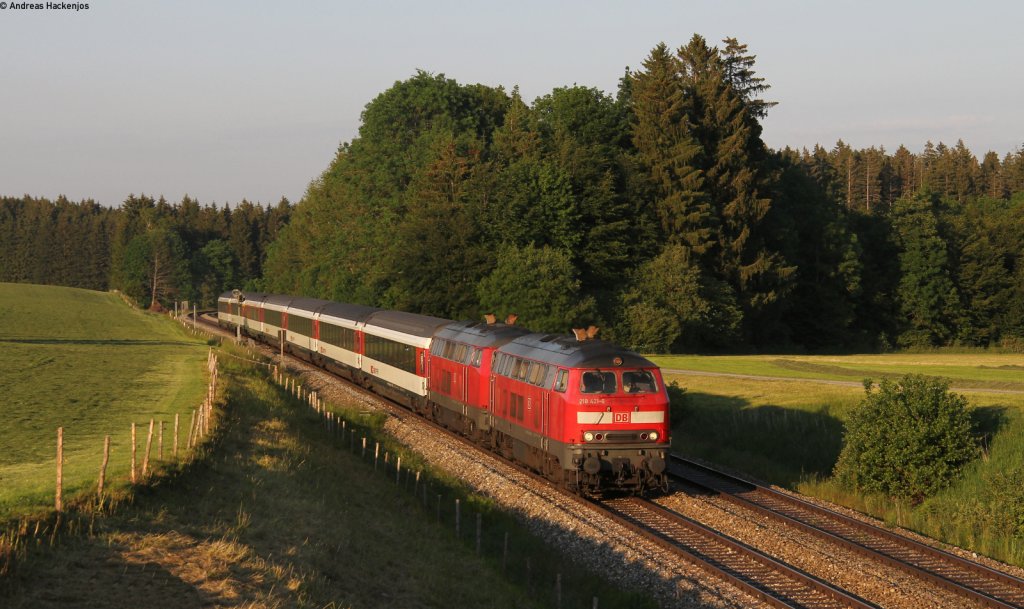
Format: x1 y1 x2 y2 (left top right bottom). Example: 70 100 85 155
670 455 1024 609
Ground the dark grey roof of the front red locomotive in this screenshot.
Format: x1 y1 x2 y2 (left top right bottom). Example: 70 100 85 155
499 334 655 368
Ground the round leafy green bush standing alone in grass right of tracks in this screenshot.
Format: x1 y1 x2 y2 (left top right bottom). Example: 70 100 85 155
835 375 979 503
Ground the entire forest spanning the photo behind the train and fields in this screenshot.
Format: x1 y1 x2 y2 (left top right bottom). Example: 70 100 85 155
0 35 1024 352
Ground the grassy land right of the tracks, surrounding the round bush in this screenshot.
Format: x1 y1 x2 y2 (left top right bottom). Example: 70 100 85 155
652 353 1024 565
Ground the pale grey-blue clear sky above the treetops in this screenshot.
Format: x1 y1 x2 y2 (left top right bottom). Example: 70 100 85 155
0 0 1024 205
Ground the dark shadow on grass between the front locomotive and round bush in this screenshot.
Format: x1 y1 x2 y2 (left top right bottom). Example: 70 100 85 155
673 392 843 488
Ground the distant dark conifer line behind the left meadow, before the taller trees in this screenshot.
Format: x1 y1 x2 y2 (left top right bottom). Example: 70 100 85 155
0 194 292 308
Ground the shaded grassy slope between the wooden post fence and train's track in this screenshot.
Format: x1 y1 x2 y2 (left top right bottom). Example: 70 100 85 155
0 339 655 609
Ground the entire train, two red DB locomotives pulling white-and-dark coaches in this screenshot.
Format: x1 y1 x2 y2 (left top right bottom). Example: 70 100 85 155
218 293 670 494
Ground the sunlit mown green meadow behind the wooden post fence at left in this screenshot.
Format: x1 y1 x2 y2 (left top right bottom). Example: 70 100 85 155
0 284 207 521
